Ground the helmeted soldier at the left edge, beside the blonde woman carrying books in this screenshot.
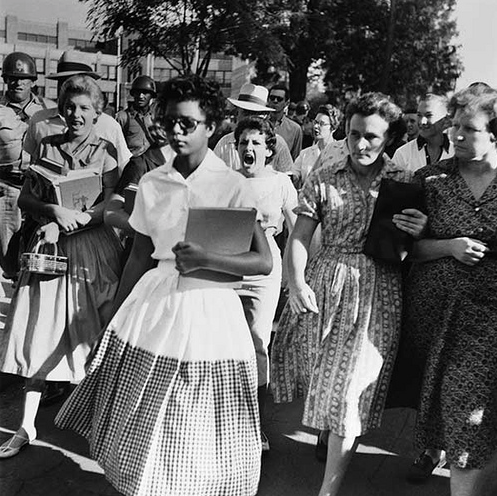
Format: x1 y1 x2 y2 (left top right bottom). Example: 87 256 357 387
0 52 56 278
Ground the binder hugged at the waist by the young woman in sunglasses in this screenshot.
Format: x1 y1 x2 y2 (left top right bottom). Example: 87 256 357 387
177 208 257 291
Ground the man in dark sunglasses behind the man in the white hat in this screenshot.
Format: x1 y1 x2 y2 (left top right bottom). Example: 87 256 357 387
268 84 302 160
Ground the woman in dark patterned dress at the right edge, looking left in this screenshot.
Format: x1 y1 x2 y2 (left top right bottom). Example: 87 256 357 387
405 88 497 496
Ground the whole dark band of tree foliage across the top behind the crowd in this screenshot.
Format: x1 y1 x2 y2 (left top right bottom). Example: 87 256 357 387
80 0 462 105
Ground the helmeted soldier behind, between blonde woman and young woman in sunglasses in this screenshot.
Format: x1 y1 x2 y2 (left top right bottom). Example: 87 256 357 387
116 76 157 157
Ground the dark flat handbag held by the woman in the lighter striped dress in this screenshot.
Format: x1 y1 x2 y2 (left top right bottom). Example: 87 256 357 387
363 178 426 264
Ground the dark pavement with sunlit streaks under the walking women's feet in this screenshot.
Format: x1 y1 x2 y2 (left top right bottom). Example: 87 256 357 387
0 281 449 496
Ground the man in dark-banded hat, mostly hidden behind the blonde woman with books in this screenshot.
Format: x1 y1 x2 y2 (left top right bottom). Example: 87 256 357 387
24 50 132 171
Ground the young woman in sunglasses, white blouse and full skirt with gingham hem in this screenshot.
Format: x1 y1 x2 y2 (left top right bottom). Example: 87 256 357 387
56 76 272 496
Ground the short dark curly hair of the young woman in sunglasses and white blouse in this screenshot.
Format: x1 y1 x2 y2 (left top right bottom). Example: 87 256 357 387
157 75 225 124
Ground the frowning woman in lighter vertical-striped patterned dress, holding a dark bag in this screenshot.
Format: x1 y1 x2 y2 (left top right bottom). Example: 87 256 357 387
271 93 426 496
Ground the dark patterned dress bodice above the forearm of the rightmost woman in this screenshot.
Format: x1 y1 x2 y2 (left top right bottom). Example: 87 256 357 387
414 157 497 246
